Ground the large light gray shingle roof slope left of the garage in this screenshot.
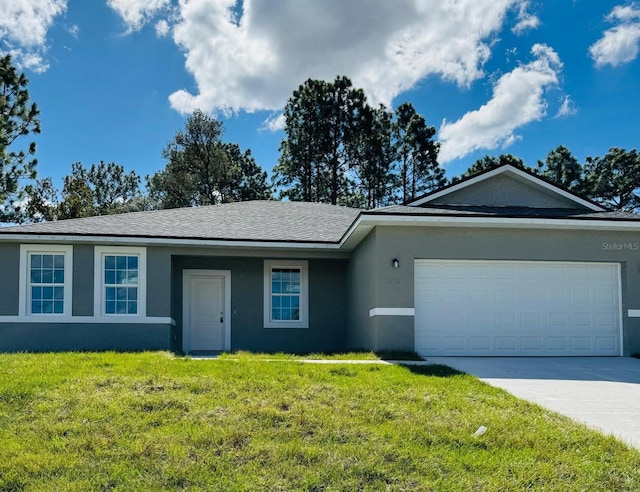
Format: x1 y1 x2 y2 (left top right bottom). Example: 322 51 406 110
0 201 360 243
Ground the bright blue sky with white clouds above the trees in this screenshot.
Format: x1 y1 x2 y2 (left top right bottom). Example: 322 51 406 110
0 0 640 187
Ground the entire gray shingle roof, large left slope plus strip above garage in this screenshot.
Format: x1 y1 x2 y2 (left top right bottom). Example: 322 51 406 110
0 201 640 244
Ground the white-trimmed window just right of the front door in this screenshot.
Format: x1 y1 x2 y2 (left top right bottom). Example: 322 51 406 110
264 260 309 328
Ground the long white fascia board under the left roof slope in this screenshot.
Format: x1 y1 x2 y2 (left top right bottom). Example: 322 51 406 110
0 234 340 250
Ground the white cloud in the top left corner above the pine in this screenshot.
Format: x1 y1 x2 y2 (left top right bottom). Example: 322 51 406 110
0 0 67 72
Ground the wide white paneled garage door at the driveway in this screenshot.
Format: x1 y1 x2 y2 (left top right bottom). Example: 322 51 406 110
415 260 622 356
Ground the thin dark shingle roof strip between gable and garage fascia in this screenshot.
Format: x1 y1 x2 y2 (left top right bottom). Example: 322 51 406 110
363 205 640 221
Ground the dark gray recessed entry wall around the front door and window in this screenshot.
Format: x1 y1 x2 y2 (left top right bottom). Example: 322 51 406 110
172 256 347 353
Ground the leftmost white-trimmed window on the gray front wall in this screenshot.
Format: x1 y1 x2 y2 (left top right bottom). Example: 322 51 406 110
18 244 73 316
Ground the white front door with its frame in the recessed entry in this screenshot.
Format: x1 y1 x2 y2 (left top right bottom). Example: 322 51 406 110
183 270 231 353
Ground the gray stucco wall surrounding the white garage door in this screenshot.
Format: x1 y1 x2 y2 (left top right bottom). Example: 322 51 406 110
349 227 640 355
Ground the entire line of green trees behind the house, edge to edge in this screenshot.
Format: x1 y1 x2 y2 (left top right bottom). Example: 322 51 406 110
0 55 640 222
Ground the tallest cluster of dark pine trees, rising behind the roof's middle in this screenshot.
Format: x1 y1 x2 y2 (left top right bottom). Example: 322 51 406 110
274 76 446 208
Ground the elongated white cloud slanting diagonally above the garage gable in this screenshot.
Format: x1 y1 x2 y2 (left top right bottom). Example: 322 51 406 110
438 44 562 163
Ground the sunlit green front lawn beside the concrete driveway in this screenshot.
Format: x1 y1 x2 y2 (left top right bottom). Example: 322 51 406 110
0 353 640 491
